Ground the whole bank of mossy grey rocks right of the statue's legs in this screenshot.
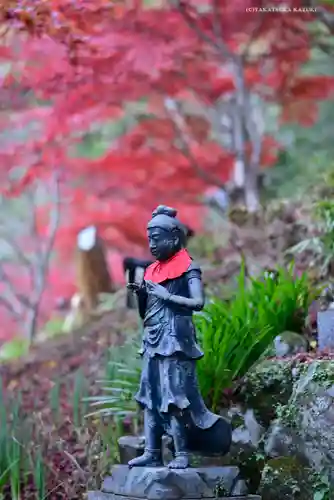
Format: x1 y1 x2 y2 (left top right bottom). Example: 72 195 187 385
229 358 334 500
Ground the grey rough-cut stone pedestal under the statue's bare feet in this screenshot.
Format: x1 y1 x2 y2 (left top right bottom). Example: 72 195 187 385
88 465 260 500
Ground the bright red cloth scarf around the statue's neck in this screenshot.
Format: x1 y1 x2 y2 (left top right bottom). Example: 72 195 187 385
144 248 192 283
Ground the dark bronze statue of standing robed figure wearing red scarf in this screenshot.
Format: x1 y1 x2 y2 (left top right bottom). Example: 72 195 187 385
128 206 231 469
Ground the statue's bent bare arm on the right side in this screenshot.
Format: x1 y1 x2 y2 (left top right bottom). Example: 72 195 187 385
168 265 205 311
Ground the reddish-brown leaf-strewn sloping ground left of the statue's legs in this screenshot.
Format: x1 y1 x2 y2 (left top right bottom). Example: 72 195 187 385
0 309 138 500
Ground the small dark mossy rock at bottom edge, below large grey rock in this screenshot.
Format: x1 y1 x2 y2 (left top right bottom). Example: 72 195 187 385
259 457 314 500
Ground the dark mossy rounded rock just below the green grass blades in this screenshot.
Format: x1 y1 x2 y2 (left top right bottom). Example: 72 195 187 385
239 359 293 428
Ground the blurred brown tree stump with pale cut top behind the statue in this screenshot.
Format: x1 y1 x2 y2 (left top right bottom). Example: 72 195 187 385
76 226 114 316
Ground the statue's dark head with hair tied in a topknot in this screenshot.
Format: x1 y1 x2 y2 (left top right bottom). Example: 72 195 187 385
147 205 187 261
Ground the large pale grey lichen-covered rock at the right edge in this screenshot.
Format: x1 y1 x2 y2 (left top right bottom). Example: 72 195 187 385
265 360 334 488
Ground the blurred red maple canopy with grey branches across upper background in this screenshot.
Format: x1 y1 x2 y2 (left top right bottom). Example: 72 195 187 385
0 0 334 340
